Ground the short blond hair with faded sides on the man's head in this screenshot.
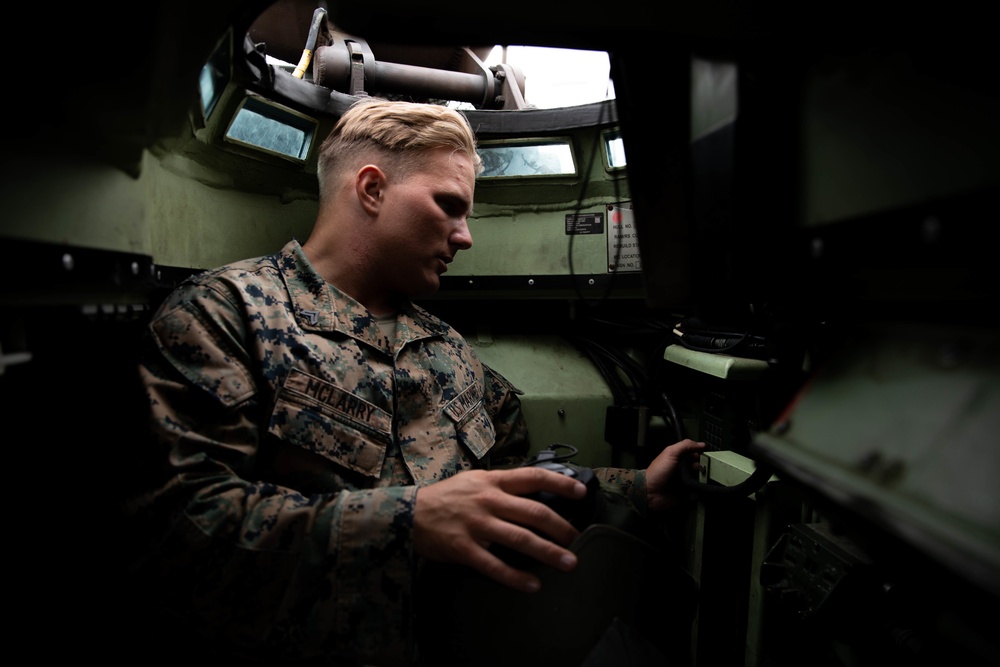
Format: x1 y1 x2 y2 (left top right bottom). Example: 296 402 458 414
317 97 483 195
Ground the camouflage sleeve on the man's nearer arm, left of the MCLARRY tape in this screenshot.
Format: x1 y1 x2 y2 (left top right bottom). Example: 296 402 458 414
129 280 416 664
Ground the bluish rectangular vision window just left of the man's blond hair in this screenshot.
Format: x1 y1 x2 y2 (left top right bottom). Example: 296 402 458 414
226 97 317 161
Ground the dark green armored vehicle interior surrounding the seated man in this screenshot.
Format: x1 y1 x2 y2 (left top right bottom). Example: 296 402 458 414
0 0 1000 667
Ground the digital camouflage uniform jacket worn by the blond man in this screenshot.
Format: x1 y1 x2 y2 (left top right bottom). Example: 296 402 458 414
130 240 645 665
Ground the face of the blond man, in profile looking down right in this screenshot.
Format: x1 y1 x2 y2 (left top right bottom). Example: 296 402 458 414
376 148 476 297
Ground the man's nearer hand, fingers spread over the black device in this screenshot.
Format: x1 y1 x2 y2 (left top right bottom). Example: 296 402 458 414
413 467 587 593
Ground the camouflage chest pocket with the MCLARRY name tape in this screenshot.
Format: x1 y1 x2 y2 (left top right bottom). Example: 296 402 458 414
268 369 392 478
